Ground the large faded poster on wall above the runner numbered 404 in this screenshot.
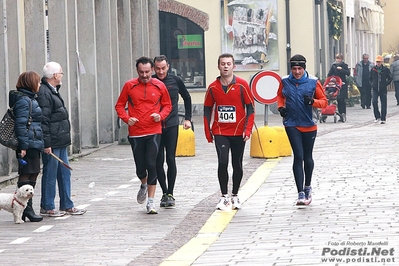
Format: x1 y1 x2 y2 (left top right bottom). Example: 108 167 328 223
221 0 279 71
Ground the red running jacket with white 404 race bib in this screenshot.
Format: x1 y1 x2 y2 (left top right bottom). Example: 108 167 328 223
204 76 255 142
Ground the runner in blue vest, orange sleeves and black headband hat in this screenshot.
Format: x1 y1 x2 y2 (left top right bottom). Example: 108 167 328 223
277 54 327 205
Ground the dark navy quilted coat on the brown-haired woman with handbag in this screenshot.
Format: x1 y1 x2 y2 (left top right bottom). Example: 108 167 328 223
8 88 44 151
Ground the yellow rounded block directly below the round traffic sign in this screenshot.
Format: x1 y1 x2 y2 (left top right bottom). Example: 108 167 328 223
250 126 280 158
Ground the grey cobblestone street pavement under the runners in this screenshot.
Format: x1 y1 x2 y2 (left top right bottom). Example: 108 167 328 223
0 92 399 266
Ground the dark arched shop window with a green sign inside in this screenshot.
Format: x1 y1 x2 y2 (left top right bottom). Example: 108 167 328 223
159 11 205 88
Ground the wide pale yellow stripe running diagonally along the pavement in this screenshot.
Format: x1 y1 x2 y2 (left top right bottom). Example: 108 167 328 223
160 157 281 266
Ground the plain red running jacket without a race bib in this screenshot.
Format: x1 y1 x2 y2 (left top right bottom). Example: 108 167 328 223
115 78 172 137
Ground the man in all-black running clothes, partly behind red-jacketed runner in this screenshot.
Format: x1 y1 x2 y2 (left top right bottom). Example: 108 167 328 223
152 55 191 207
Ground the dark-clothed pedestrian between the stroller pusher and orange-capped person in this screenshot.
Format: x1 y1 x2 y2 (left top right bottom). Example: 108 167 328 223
353 54 376 109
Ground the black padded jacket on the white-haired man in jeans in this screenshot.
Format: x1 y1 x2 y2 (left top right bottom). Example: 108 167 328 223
37 78 71 149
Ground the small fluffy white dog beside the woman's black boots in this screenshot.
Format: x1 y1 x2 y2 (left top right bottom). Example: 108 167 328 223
0 185 35 224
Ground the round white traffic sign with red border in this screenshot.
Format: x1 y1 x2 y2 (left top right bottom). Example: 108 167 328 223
249 70 281 104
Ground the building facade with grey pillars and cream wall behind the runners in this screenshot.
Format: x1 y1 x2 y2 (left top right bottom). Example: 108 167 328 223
0 0 395 176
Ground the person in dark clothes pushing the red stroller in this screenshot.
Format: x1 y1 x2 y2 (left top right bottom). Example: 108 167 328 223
327 54 350 122
